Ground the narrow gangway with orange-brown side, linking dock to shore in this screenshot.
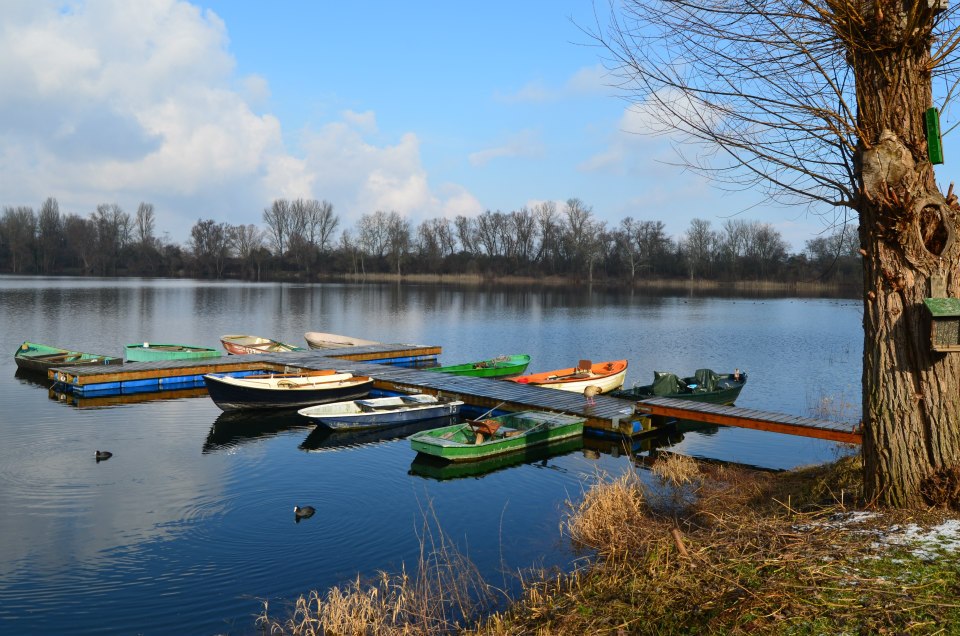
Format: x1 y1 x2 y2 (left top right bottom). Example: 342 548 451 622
636 398 863 444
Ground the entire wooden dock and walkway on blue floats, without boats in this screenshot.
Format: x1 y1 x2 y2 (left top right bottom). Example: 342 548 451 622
49 344 861 444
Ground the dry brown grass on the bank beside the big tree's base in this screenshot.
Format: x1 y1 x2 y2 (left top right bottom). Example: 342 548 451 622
480 458 960 636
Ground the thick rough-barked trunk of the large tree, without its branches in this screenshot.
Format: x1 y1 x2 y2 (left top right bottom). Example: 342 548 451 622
850 0 960 507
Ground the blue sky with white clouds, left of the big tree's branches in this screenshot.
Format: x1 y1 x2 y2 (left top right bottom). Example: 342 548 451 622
0 0 949 250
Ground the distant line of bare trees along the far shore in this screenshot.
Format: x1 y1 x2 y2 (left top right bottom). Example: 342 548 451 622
0 198 861 286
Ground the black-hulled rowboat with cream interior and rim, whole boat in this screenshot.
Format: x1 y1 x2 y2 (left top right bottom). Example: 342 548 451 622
203 370 373 411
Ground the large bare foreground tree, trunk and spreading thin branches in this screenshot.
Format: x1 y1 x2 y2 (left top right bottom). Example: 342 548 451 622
593 0 960 507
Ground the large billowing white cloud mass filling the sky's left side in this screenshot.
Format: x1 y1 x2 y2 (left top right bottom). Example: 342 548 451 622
0 0 478 242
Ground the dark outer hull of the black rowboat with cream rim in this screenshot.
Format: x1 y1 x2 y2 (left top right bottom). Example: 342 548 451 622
203 373 373 411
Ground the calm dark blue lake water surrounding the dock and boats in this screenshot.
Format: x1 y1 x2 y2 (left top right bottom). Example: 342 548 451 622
0 277 863 634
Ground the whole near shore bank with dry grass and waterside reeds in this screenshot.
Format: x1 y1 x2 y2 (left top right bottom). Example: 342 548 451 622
260 454 960 636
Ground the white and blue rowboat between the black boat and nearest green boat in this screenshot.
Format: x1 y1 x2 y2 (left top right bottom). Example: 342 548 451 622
297 393 463 430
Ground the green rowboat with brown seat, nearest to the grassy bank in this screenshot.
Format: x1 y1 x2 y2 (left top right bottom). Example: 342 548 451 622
410 411 584 462
